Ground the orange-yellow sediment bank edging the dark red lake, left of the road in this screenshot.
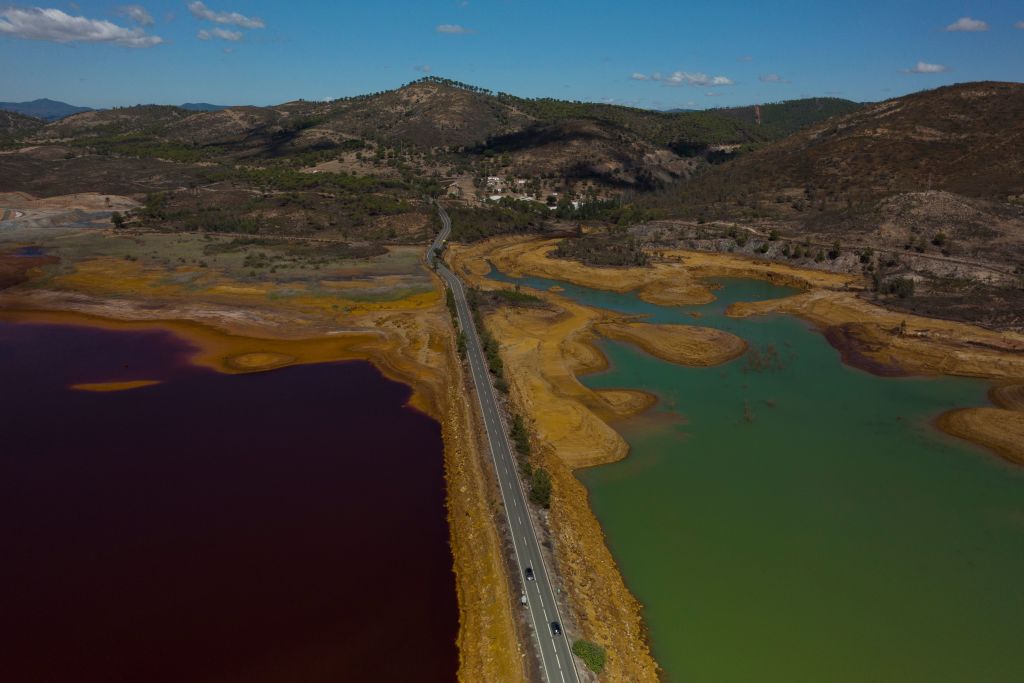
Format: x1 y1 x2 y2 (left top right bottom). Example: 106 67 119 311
0 270 526 682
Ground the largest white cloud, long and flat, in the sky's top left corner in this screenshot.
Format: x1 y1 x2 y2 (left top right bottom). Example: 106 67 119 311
0 7 164 47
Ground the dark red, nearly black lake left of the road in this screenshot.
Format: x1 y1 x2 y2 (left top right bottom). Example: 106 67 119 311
0 323 458 683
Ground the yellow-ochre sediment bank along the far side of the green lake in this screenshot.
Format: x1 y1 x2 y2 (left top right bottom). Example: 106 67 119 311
483 239 1024 471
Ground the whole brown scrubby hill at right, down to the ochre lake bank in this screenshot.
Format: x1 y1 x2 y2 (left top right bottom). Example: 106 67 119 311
637 82 1024 328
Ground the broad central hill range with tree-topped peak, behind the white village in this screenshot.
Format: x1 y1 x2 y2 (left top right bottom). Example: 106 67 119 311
4 77 860 193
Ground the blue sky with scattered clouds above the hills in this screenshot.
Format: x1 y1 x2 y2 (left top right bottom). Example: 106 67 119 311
0 0 1024 109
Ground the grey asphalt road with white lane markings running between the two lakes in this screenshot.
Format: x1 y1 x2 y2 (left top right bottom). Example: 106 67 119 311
427 205 580 683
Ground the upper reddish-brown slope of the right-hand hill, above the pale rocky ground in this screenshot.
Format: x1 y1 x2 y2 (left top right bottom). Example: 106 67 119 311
655 83 1024 217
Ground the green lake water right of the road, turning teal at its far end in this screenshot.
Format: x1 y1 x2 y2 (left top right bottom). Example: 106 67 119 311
496 275 1024 683
